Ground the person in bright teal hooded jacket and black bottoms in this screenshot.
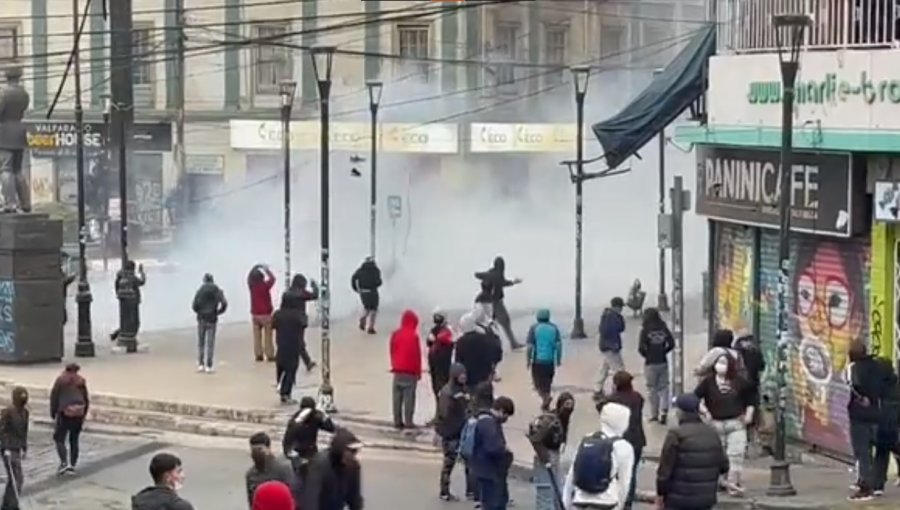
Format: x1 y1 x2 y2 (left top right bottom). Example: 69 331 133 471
526 309 562 411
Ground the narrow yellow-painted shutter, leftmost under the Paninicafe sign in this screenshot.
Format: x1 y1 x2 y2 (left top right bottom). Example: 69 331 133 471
714 223 755 332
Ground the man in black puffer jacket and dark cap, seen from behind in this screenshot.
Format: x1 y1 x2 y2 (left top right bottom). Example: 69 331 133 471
656 393 730 510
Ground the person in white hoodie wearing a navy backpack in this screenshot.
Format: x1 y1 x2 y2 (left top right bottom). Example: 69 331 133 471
562 402 634 510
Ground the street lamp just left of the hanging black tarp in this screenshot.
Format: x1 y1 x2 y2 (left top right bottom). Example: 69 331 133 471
569 66 591 339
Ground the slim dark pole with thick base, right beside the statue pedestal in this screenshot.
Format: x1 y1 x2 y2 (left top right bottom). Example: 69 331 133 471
72 0 95 358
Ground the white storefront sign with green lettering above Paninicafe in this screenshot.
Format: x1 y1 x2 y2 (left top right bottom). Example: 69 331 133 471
707 50 900 130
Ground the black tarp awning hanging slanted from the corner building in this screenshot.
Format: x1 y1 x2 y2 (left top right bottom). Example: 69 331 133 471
592 24 716 169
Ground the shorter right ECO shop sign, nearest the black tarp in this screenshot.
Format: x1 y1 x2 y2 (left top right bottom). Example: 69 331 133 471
470 123 577 153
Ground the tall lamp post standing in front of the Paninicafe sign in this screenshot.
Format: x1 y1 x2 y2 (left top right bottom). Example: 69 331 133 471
766 14 810 496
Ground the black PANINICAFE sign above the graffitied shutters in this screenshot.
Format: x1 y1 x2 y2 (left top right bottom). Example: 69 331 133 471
697 146 865 237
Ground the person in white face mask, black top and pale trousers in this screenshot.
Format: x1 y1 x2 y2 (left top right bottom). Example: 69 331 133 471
694 354 755 496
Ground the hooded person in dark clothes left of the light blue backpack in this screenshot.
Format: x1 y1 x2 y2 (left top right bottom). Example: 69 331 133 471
434 363 472 501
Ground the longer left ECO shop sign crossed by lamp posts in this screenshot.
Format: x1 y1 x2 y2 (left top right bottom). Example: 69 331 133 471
231 120 459 154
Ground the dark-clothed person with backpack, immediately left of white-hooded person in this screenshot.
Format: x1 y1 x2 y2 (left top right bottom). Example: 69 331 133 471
528 392 575 510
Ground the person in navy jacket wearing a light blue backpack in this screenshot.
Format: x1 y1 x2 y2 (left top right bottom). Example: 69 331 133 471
459 397 516 510
